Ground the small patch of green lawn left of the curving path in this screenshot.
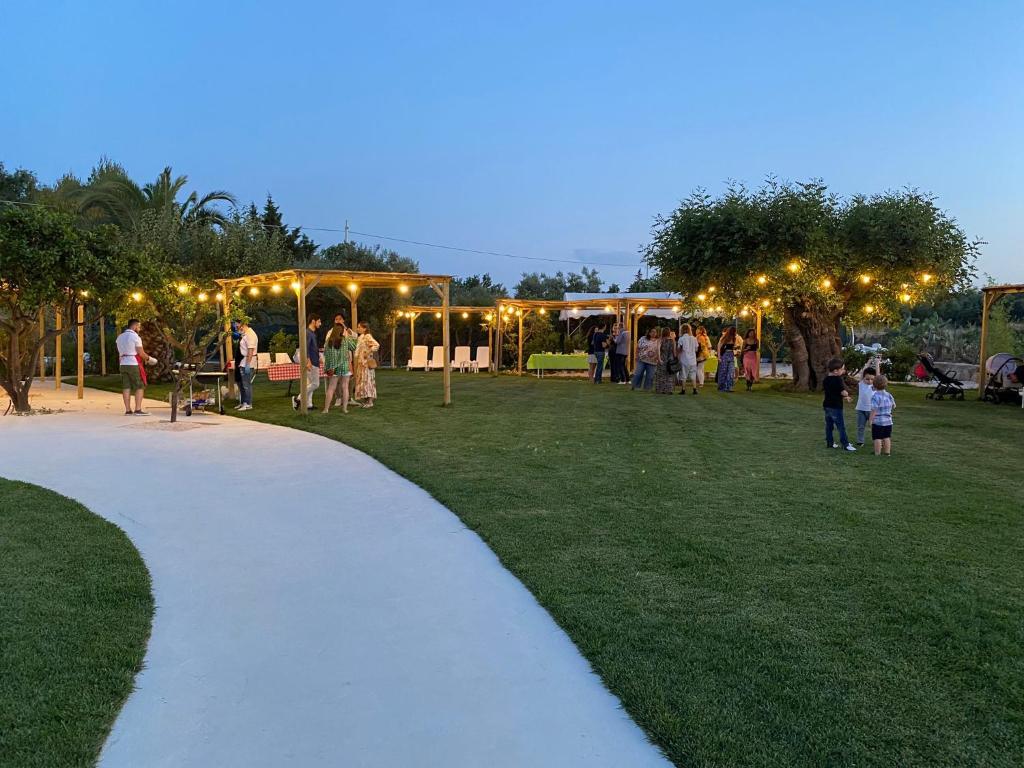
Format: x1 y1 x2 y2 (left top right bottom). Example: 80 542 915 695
0 479 153 768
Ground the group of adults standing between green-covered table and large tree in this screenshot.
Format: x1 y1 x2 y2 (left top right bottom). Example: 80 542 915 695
588 323 761 394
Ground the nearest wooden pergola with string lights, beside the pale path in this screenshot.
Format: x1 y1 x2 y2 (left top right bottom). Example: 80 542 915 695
216 269 452 414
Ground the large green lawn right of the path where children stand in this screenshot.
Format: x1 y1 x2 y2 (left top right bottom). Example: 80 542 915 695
86 371 1024 766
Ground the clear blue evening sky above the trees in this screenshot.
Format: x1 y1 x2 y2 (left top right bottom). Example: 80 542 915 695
0 0 1024 285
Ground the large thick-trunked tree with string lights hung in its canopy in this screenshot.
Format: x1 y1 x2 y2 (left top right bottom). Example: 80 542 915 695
647 180 979 390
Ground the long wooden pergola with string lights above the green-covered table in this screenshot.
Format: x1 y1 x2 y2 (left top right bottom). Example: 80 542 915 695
490 296 762 376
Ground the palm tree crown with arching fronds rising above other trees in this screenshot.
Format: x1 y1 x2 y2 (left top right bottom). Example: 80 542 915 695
78 160 237 232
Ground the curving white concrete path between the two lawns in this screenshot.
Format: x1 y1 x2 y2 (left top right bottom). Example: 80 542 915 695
0 388 668 768
